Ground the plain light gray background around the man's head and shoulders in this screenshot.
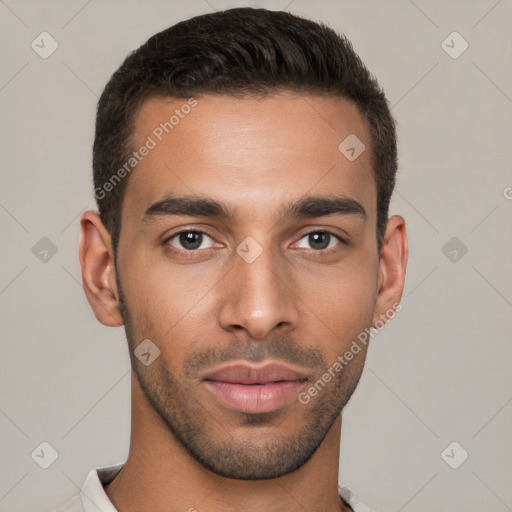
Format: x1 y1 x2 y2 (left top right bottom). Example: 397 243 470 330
0 0 512 512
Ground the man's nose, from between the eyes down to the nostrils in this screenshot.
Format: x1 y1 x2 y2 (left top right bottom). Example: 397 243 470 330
219 244 299 339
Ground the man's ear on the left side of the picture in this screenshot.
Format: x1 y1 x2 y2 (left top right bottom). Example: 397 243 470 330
80 210 123 327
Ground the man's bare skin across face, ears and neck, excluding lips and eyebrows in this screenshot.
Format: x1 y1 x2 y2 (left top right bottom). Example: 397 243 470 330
80 93 408 512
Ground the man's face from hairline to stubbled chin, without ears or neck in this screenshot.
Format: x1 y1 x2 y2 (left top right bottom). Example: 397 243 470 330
99 95 400 479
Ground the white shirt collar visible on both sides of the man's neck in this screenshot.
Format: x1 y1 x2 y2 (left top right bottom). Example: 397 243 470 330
53 462 373 512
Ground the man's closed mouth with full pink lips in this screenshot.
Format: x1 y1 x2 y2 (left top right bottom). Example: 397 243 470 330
202 362 307 414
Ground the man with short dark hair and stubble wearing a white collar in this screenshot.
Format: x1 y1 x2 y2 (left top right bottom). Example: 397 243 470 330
56 8 408 512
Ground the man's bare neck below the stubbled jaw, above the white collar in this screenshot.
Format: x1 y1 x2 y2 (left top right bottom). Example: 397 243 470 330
105 373 350 512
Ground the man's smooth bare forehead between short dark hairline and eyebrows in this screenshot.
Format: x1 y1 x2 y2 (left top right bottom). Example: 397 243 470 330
123 94 376 224
